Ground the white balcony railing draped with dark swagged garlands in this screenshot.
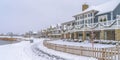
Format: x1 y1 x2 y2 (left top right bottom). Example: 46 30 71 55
62 19 120 31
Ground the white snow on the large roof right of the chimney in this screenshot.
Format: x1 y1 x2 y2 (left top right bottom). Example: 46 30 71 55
74 0 120 15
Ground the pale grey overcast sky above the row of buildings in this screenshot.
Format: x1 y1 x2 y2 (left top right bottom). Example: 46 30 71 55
0 0 110 33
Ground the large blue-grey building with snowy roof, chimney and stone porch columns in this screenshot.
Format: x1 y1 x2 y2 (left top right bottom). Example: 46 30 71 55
62 0 120 41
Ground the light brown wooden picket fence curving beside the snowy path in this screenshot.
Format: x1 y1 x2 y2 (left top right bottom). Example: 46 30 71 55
43 40 120 60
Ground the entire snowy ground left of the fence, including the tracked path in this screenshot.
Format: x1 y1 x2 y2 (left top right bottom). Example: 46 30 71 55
0 38 96 60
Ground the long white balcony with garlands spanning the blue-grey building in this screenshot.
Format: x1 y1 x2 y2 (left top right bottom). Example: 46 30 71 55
62 20 120 32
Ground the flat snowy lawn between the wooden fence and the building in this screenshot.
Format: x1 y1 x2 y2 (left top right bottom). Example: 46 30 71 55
49 40 115 48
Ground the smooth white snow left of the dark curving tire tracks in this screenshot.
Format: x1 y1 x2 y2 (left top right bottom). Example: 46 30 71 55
0 39 49 60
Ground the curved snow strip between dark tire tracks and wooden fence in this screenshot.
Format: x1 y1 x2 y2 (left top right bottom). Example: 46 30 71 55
31 40 97 60
